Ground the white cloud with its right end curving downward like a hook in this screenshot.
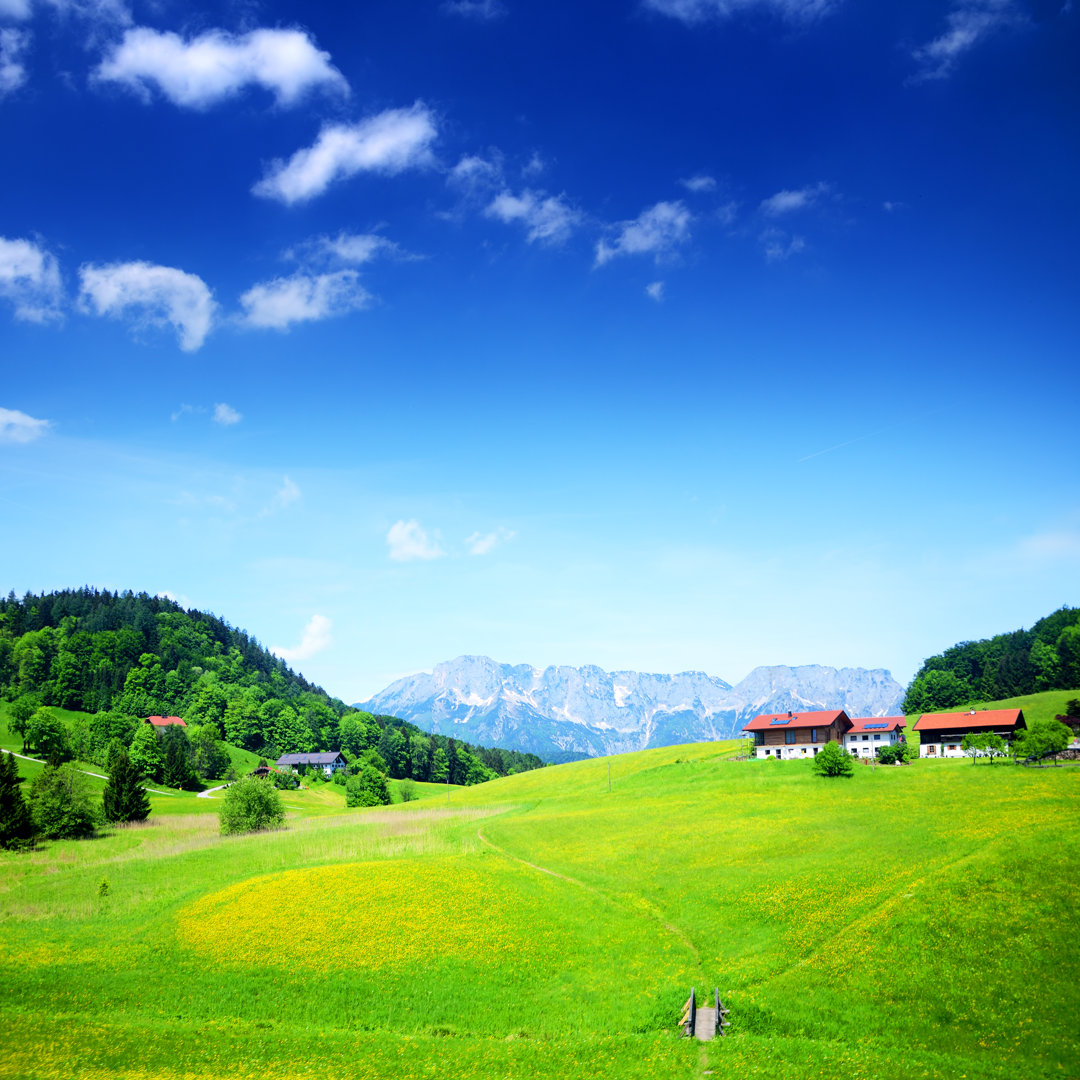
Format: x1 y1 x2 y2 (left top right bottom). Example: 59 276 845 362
79 262 217 352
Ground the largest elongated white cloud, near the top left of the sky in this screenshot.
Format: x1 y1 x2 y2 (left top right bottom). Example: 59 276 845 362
94 26 349 109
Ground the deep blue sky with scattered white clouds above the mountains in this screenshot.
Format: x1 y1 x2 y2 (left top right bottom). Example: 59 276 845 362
0 0 1080 701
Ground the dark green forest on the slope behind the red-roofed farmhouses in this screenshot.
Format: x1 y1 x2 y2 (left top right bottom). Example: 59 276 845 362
902 607 1080 716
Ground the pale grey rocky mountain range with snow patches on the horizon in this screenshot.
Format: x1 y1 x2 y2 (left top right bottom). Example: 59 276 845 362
359 657 904 761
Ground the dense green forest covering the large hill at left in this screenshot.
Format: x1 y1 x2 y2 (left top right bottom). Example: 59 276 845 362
0 589 543 784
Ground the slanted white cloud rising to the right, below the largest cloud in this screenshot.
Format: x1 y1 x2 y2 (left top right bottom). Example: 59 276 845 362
252 102 437 204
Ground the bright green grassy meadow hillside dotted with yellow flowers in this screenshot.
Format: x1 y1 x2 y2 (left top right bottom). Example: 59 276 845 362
0 743 1080 1080
